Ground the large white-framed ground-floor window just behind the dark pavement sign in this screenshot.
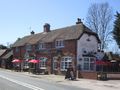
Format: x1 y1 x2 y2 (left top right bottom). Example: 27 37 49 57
61 57 72 71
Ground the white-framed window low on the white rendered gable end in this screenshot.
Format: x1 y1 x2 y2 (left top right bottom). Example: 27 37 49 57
83 57 95 71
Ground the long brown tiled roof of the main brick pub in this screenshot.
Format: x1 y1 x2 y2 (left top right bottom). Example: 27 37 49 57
13 24 100 47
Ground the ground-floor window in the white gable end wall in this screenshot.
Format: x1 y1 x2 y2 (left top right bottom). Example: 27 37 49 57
83 57 95 71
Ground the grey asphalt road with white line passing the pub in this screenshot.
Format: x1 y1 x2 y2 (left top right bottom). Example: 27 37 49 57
0 69 87 90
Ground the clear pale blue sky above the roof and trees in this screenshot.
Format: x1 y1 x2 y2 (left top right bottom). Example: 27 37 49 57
0 0 120 51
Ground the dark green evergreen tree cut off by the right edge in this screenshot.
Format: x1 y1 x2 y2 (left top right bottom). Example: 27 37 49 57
113 12 120 48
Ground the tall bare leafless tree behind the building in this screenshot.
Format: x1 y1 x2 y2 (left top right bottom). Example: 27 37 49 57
86 3 112 50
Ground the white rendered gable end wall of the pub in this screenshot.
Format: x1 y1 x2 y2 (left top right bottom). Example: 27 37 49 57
77 33 98 69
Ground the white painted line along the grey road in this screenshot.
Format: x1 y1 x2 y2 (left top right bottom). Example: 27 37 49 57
0 75 45 90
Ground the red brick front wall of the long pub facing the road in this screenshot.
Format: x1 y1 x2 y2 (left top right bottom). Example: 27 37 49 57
13 40 76 74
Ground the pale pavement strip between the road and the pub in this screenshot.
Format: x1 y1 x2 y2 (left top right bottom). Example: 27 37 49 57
0 68 120 90
